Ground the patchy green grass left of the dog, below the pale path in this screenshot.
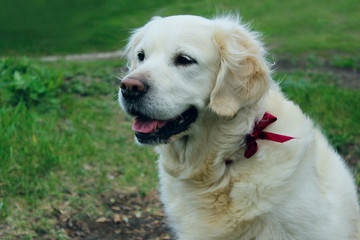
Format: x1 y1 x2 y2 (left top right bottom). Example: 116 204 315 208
0 59 157 239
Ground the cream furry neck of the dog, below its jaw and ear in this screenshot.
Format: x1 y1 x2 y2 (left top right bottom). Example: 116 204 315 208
157 100 264 183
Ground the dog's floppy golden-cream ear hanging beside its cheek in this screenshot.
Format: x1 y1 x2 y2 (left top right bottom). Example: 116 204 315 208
210 17 271 117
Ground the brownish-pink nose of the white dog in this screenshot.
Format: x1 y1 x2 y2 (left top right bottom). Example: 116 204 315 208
120 77 149 98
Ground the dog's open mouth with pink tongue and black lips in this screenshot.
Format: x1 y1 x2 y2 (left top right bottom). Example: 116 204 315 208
132 107 197 144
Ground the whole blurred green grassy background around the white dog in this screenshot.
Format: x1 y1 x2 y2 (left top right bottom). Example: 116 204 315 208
0 0 360 239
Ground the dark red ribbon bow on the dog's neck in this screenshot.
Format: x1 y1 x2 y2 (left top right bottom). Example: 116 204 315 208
244 112 294 158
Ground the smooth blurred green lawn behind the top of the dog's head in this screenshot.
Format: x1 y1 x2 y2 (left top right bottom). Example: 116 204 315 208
0 0 360 56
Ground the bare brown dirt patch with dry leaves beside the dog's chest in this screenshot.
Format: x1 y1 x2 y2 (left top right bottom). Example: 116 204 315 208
56 191 174 240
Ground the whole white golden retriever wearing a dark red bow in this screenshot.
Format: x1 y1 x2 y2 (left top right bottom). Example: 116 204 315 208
119 16 360 240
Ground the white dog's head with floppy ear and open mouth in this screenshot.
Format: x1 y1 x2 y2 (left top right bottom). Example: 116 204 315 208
119 16 270 144
